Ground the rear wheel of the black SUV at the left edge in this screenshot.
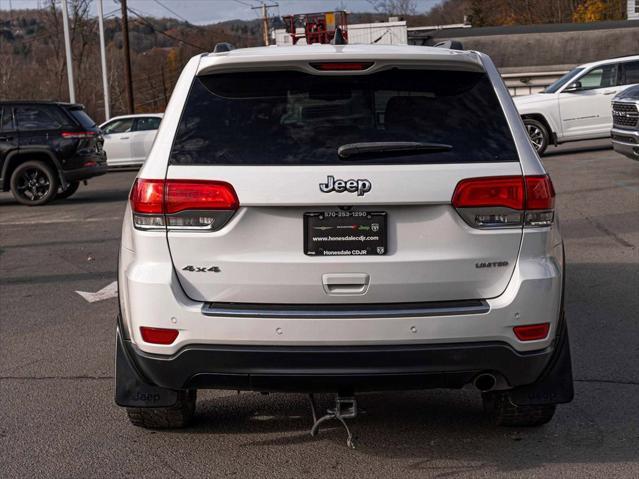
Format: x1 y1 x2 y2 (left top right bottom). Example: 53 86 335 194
11 161 59 206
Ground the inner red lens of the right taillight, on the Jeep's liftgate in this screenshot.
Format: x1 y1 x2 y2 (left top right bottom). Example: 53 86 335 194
453 176 525 210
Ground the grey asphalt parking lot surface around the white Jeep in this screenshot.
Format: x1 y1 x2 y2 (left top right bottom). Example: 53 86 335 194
0 141 639 478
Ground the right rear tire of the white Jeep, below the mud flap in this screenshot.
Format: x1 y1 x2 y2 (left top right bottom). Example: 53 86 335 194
482 391 556 427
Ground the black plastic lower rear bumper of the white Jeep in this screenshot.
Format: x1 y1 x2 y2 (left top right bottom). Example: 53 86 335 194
118 326 554 392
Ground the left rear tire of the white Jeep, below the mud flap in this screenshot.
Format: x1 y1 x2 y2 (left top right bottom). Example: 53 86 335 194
126 389 197 429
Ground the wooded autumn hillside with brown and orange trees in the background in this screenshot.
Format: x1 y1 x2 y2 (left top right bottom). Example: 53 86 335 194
0 0 626 121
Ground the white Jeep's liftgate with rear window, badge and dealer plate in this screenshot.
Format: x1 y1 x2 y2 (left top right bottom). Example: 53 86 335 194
159 61 522 304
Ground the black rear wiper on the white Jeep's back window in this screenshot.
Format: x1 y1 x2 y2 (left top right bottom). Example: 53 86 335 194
337 141 453 160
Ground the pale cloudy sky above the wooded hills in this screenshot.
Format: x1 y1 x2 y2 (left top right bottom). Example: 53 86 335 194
0 0 441 24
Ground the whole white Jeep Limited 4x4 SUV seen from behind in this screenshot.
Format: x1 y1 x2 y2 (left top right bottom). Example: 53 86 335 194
116 45 573 427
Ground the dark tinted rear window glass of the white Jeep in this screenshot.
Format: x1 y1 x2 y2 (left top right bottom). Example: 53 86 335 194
170 68 517 165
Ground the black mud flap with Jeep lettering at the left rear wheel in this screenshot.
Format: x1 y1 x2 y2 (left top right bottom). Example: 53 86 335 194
115 328 178 407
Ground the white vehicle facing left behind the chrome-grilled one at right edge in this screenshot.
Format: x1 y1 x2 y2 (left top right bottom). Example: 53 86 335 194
513 55 639 155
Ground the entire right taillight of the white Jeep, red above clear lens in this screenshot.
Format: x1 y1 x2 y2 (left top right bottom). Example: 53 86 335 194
452 175 555 228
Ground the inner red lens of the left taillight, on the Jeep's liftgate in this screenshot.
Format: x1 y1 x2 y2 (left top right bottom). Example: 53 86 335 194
166 180 238 214
